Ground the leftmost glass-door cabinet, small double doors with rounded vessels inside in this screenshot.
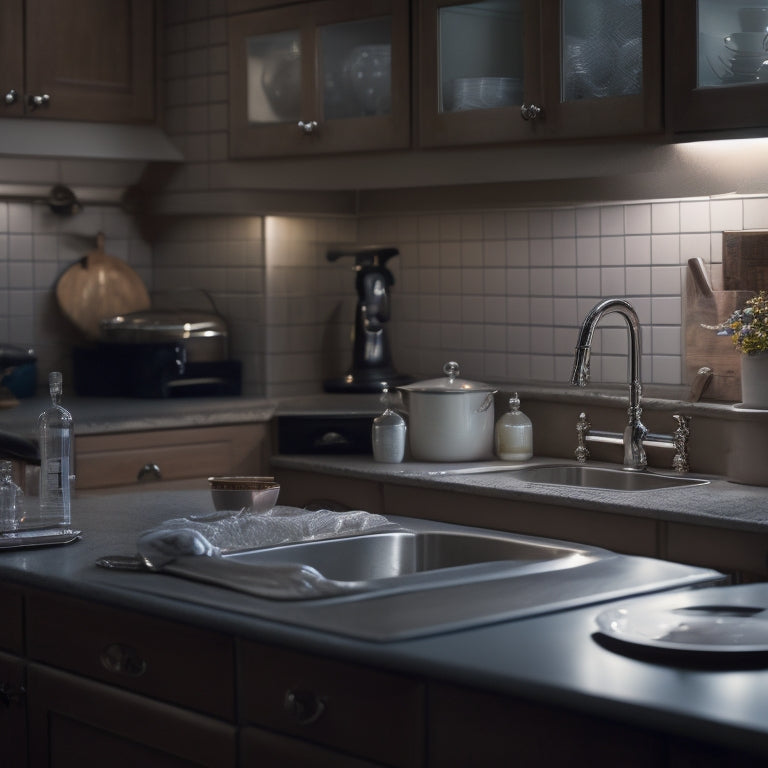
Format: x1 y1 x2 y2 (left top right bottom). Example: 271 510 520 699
229 0 410 157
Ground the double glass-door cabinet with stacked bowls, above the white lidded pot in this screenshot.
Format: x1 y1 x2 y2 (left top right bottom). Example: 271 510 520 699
418 0 661 147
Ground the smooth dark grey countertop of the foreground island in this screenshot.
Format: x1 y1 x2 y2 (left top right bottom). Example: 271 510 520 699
0 491 768 752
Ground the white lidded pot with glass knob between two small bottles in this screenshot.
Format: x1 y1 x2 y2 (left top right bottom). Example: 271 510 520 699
398 363 496 461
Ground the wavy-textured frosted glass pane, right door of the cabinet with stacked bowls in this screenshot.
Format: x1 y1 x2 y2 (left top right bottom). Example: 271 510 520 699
561 0 643 101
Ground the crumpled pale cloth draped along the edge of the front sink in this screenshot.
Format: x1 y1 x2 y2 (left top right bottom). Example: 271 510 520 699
137 506 399 562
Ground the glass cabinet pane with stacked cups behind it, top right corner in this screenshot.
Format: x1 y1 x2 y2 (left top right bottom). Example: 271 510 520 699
697 0 768 88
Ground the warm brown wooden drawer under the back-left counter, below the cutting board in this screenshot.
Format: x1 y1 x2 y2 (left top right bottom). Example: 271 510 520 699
75 424 267 490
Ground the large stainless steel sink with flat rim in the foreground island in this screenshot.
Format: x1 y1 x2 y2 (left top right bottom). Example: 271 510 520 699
141 516 722 640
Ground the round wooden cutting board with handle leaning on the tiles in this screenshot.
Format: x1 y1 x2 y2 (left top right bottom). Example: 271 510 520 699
56 232 150 340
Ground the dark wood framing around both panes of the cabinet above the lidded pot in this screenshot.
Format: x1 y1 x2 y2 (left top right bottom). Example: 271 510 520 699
418 0 662 147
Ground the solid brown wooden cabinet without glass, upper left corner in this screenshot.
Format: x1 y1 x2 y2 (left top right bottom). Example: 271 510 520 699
0 0 155 123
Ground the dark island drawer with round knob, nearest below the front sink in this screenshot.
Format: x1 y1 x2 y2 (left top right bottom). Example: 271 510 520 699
238 642 424 768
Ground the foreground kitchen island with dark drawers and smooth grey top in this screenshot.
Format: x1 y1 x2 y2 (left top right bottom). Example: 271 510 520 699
0 491 768 768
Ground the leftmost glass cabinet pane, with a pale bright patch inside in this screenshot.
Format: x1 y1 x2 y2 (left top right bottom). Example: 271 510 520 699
246 30 301 123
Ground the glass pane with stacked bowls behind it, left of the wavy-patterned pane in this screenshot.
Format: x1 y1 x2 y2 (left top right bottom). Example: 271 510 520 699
438 0 524 112
